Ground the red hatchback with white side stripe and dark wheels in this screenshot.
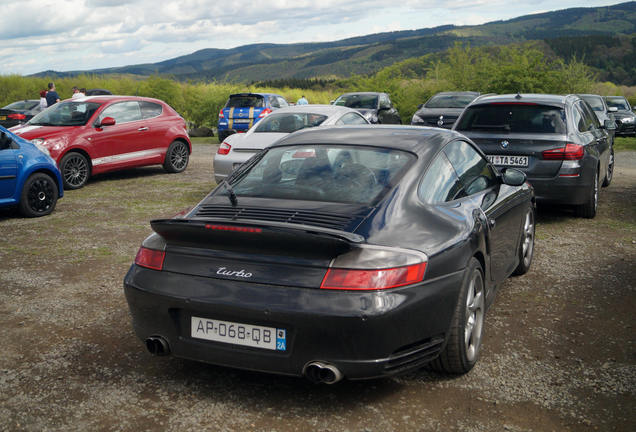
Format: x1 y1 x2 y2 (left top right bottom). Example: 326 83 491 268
11 96 192 189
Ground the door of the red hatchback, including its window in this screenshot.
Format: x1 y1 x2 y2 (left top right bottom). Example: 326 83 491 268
89 101 148 172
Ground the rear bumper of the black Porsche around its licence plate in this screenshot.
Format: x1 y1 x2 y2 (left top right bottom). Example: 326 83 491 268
124 265 463 379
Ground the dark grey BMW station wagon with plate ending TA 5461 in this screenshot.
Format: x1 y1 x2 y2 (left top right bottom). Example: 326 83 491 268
454 94 613 218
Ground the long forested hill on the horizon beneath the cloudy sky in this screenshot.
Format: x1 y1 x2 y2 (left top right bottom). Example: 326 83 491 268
29 1 636 85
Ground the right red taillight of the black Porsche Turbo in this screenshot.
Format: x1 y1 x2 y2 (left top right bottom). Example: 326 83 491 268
320 262 426 290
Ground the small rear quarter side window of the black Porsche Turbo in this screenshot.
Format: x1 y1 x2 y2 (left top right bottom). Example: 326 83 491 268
417 152 466 204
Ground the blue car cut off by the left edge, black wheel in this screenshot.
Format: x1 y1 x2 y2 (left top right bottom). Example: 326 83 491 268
0 126 64 217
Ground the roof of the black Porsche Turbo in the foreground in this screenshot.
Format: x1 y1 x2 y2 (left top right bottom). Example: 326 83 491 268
272 125 467 155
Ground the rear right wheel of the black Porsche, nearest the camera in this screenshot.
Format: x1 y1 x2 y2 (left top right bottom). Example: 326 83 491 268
430 258 486 374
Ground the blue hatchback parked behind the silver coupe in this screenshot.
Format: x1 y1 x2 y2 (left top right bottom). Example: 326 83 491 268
218 93 289 142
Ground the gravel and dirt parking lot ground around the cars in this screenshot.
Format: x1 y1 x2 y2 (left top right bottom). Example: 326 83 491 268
0 145 636 432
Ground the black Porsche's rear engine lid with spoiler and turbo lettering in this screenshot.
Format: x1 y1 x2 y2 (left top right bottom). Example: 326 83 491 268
151 199 370 288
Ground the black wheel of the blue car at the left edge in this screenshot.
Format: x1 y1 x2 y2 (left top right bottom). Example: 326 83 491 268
19 173 59 217
